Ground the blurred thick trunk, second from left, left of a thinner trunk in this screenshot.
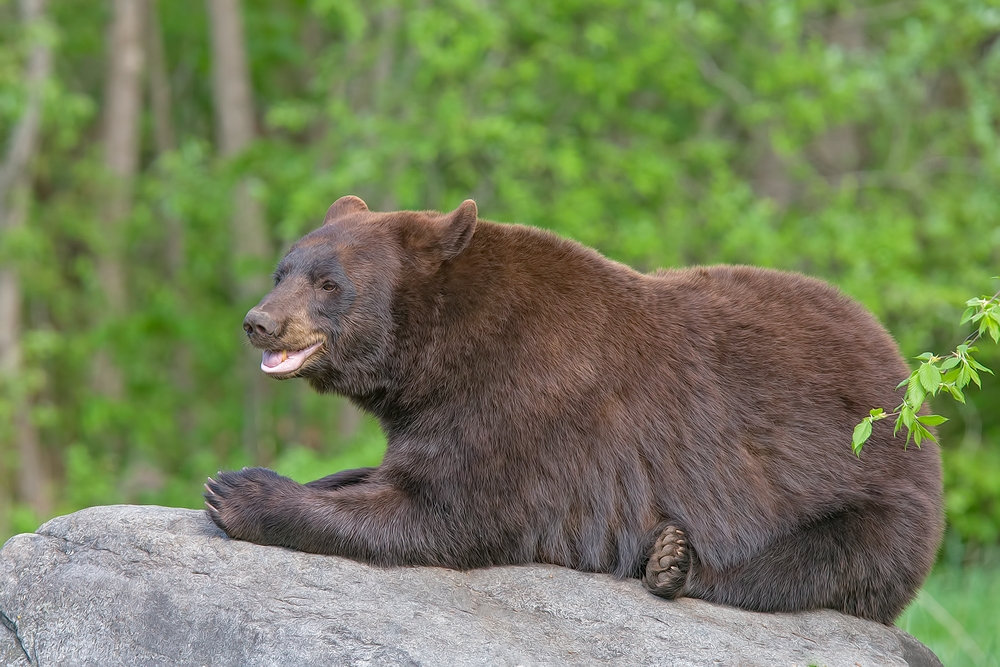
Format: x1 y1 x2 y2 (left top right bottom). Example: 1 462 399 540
94 0 146 400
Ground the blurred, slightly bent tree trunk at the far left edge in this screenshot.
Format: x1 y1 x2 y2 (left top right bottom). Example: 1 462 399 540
0 0 52 534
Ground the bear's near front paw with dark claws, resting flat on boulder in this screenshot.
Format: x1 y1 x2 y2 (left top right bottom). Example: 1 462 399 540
205 468 299 544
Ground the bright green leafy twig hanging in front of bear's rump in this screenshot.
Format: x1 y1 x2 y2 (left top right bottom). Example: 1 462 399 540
851 284 1000 456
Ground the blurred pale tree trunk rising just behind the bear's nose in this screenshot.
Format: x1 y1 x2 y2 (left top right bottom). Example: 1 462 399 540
208 0 274 464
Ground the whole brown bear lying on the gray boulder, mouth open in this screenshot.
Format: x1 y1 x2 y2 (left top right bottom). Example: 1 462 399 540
205 197 943 623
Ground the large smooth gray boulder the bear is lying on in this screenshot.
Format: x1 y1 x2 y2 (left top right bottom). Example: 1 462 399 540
0 506 940 667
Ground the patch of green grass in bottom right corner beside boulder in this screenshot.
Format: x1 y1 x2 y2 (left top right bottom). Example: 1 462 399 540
896 559 1000 667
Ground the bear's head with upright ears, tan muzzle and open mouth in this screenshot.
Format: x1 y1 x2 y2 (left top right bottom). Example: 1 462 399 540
243 196 477 397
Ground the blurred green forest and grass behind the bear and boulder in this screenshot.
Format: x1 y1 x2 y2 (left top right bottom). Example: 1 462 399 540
0 0 1000 665
